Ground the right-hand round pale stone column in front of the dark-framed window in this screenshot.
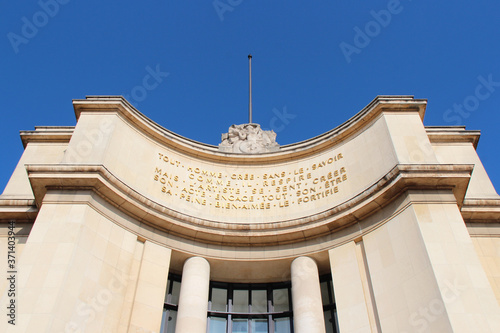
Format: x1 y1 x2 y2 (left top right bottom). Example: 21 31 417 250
292 257 325 333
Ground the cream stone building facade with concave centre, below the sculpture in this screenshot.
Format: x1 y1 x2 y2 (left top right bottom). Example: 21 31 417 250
0 96 500 333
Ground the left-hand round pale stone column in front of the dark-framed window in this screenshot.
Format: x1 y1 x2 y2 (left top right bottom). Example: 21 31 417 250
175 257 210 333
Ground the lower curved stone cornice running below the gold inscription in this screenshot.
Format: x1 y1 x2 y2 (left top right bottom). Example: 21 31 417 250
27 164 473 246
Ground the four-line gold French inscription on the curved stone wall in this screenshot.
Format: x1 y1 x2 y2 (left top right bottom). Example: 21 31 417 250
152 152 348 211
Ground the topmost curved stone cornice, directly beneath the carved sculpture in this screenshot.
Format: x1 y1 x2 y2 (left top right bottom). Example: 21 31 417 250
73 96 427 165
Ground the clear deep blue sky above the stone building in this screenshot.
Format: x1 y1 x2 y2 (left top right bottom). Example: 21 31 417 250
0 0 500 192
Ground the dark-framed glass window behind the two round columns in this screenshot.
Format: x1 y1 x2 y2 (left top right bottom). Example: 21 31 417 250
160 274 338 333
